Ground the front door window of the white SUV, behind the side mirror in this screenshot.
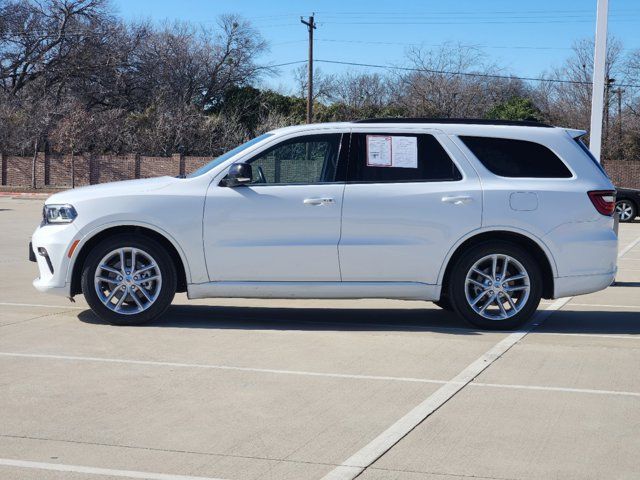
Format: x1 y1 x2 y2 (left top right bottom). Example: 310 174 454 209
247 134 341 185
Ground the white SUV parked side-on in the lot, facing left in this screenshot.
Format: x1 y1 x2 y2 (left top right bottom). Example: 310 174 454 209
30 119 617 329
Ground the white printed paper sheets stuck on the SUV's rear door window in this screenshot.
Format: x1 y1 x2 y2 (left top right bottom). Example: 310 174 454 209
367 135 418 168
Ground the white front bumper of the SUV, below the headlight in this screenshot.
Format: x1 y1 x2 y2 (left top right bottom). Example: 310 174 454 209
29 223 78 297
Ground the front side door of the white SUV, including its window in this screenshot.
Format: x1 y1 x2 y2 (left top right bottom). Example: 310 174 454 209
204 133 348 282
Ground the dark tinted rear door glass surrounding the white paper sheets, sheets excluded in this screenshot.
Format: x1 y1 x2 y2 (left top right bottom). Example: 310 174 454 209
347 133 462 183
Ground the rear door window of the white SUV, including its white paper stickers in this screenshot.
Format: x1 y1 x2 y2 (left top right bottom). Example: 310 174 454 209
347 132 462 183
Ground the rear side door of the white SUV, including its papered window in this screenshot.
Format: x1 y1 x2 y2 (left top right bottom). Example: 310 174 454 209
338 129 482 284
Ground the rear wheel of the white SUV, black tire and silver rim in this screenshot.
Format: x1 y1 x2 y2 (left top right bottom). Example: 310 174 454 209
447 242 542 330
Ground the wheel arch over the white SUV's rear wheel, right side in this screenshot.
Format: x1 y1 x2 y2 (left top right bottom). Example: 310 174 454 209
438 229 557 298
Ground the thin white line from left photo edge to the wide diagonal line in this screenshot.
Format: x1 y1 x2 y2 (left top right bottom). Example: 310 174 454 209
0 352 449 385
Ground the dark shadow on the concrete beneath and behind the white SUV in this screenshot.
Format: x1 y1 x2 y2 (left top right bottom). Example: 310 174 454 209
78 305 640 335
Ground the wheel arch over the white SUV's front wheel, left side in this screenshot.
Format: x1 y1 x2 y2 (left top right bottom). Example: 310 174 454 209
69 223 190 297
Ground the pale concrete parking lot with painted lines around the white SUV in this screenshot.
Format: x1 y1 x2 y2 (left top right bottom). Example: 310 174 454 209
0 198 640 480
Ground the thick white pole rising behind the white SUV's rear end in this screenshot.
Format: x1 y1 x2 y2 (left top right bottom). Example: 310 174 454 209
589 0 609 162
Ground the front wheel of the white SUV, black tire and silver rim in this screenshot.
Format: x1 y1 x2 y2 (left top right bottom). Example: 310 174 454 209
81 233 177 325
